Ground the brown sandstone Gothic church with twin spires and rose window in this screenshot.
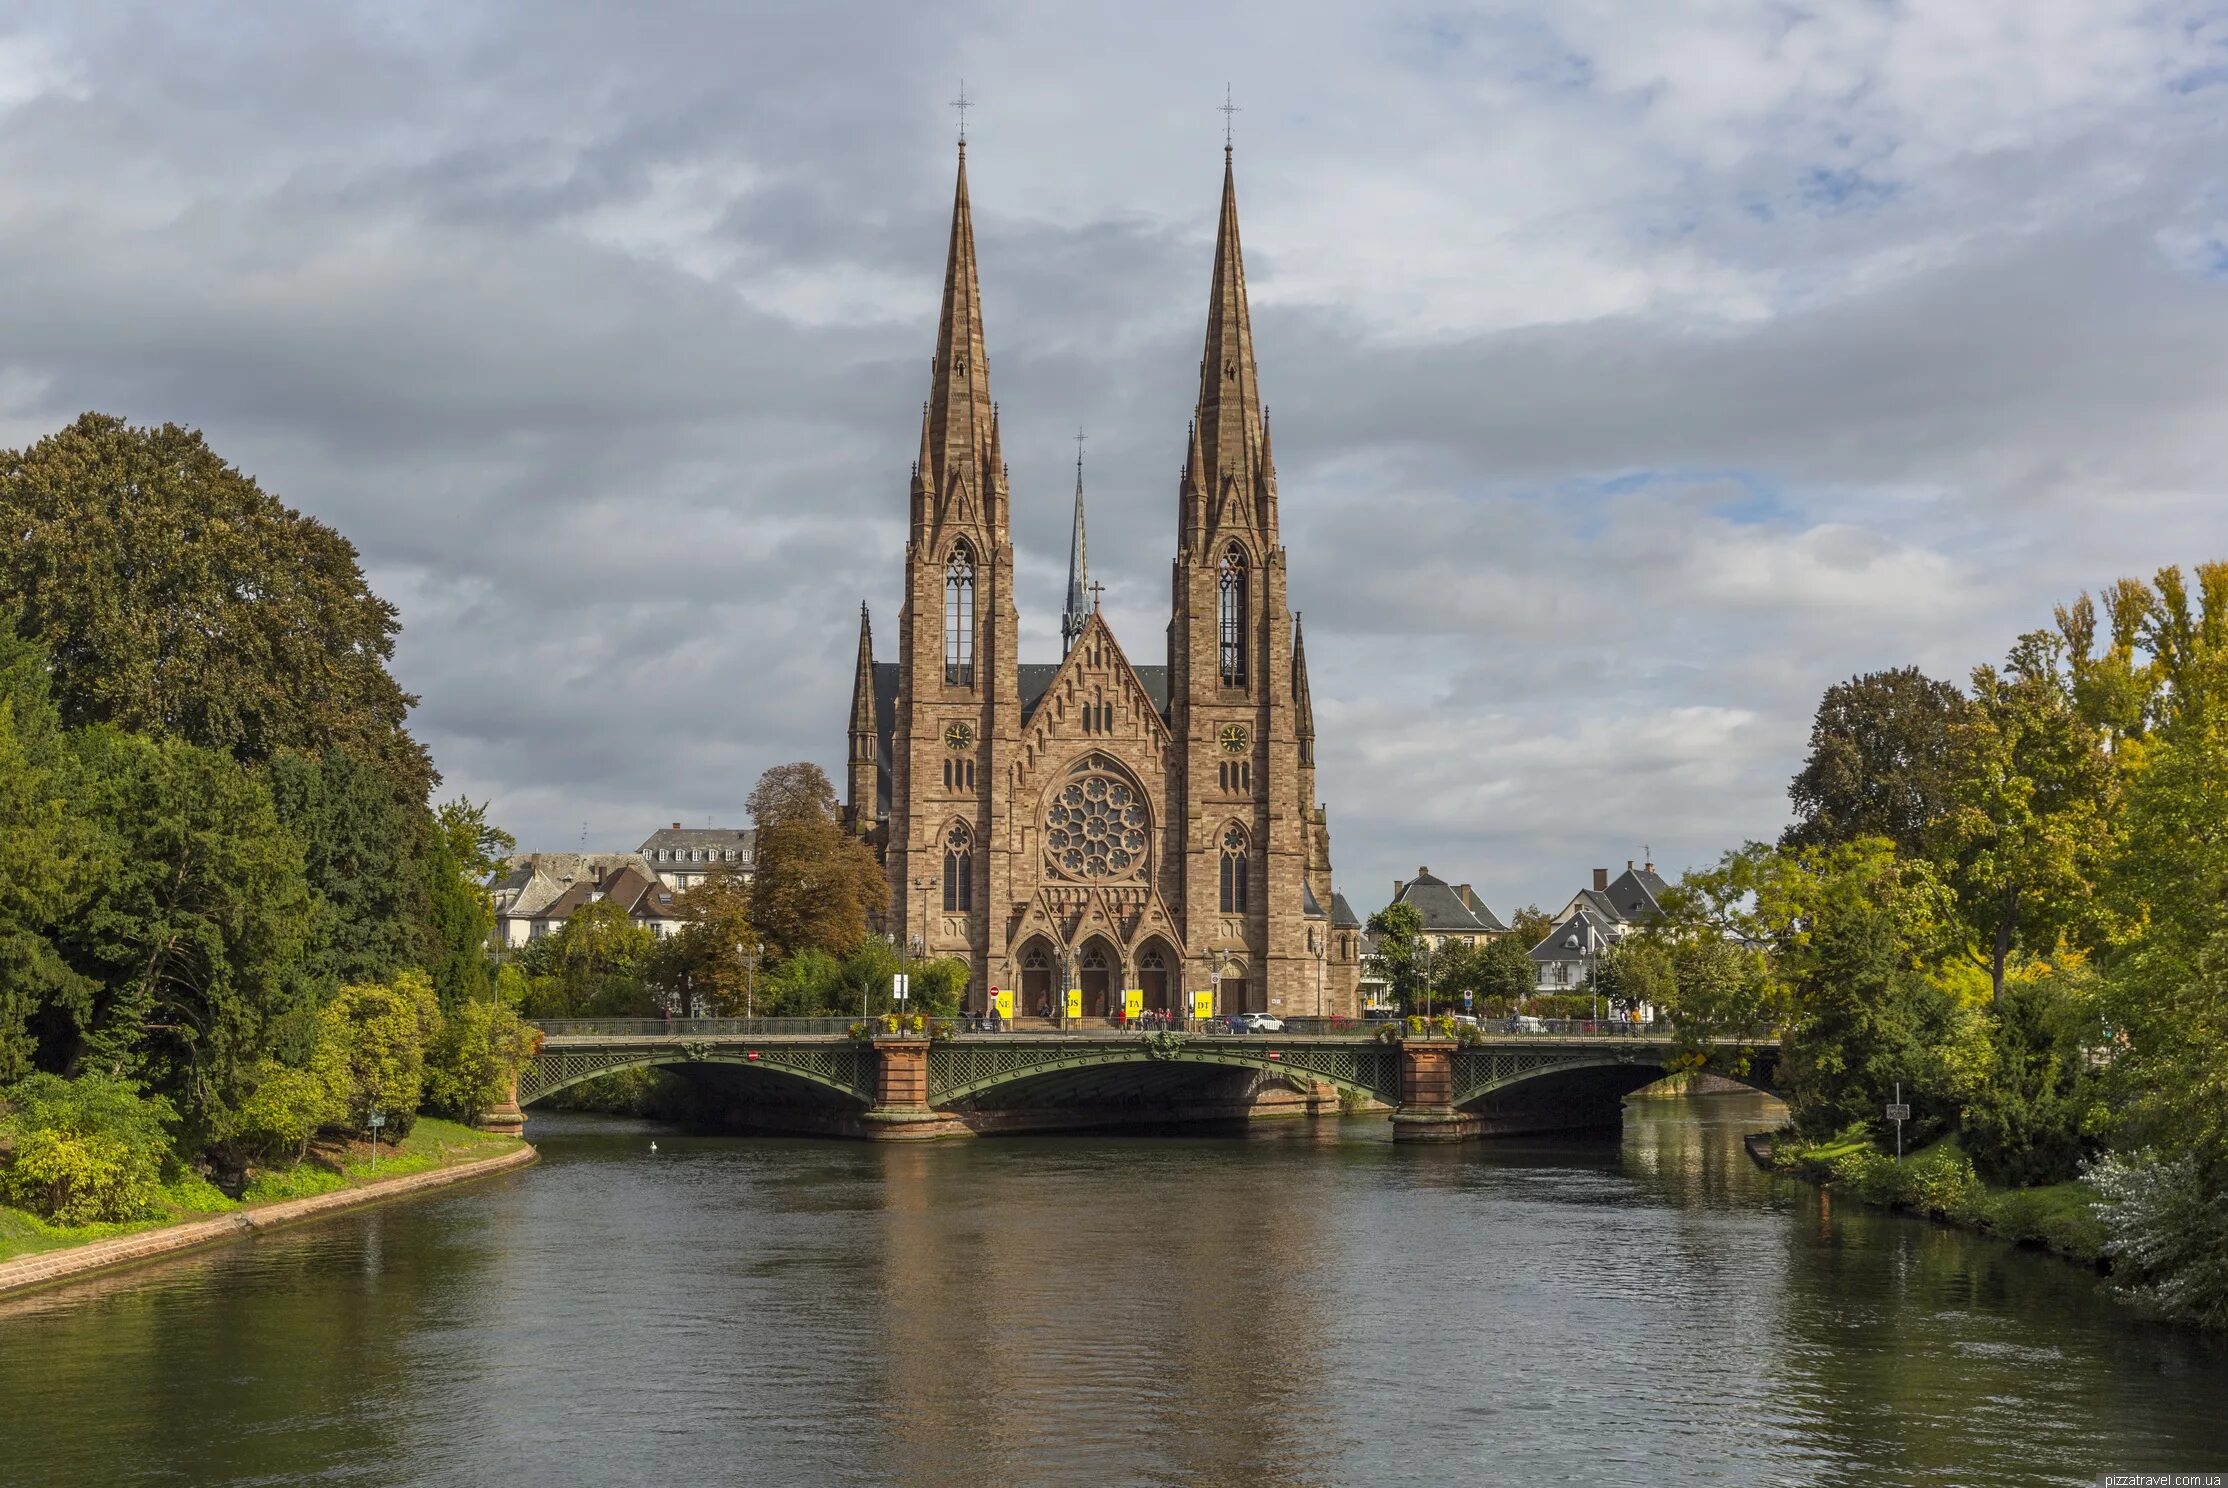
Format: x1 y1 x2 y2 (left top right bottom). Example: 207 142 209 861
847 143 1361 1016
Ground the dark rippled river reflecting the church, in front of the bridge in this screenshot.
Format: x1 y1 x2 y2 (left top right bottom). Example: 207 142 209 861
0 1096 2228 1488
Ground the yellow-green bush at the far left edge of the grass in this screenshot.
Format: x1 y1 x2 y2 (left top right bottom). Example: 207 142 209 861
0 1074 178 1225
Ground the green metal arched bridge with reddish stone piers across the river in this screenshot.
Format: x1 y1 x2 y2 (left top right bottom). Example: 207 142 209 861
490 1018 1778 1141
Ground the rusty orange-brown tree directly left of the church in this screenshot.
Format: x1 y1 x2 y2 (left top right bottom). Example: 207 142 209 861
751 764 889 958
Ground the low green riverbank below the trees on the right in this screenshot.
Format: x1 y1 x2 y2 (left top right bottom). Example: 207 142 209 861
1745 1132 2105 1270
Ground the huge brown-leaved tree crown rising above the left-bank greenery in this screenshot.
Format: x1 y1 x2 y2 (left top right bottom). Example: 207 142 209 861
0 414 434 802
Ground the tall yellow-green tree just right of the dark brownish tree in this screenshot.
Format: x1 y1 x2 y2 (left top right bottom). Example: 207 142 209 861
1932 630 2112 996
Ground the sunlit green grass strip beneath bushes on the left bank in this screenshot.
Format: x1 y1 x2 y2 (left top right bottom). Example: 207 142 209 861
0 1116 526 1261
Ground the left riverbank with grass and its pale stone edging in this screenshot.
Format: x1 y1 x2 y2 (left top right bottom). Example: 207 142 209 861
0 1118 537 1296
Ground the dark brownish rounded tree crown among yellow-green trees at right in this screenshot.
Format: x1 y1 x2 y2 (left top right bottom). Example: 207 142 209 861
1780 666 1965 853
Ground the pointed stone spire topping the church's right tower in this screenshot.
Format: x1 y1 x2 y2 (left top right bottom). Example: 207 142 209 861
1185 145 1274 539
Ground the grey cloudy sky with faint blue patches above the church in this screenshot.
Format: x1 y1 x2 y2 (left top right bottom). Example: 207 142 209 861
0 0 2228 911
